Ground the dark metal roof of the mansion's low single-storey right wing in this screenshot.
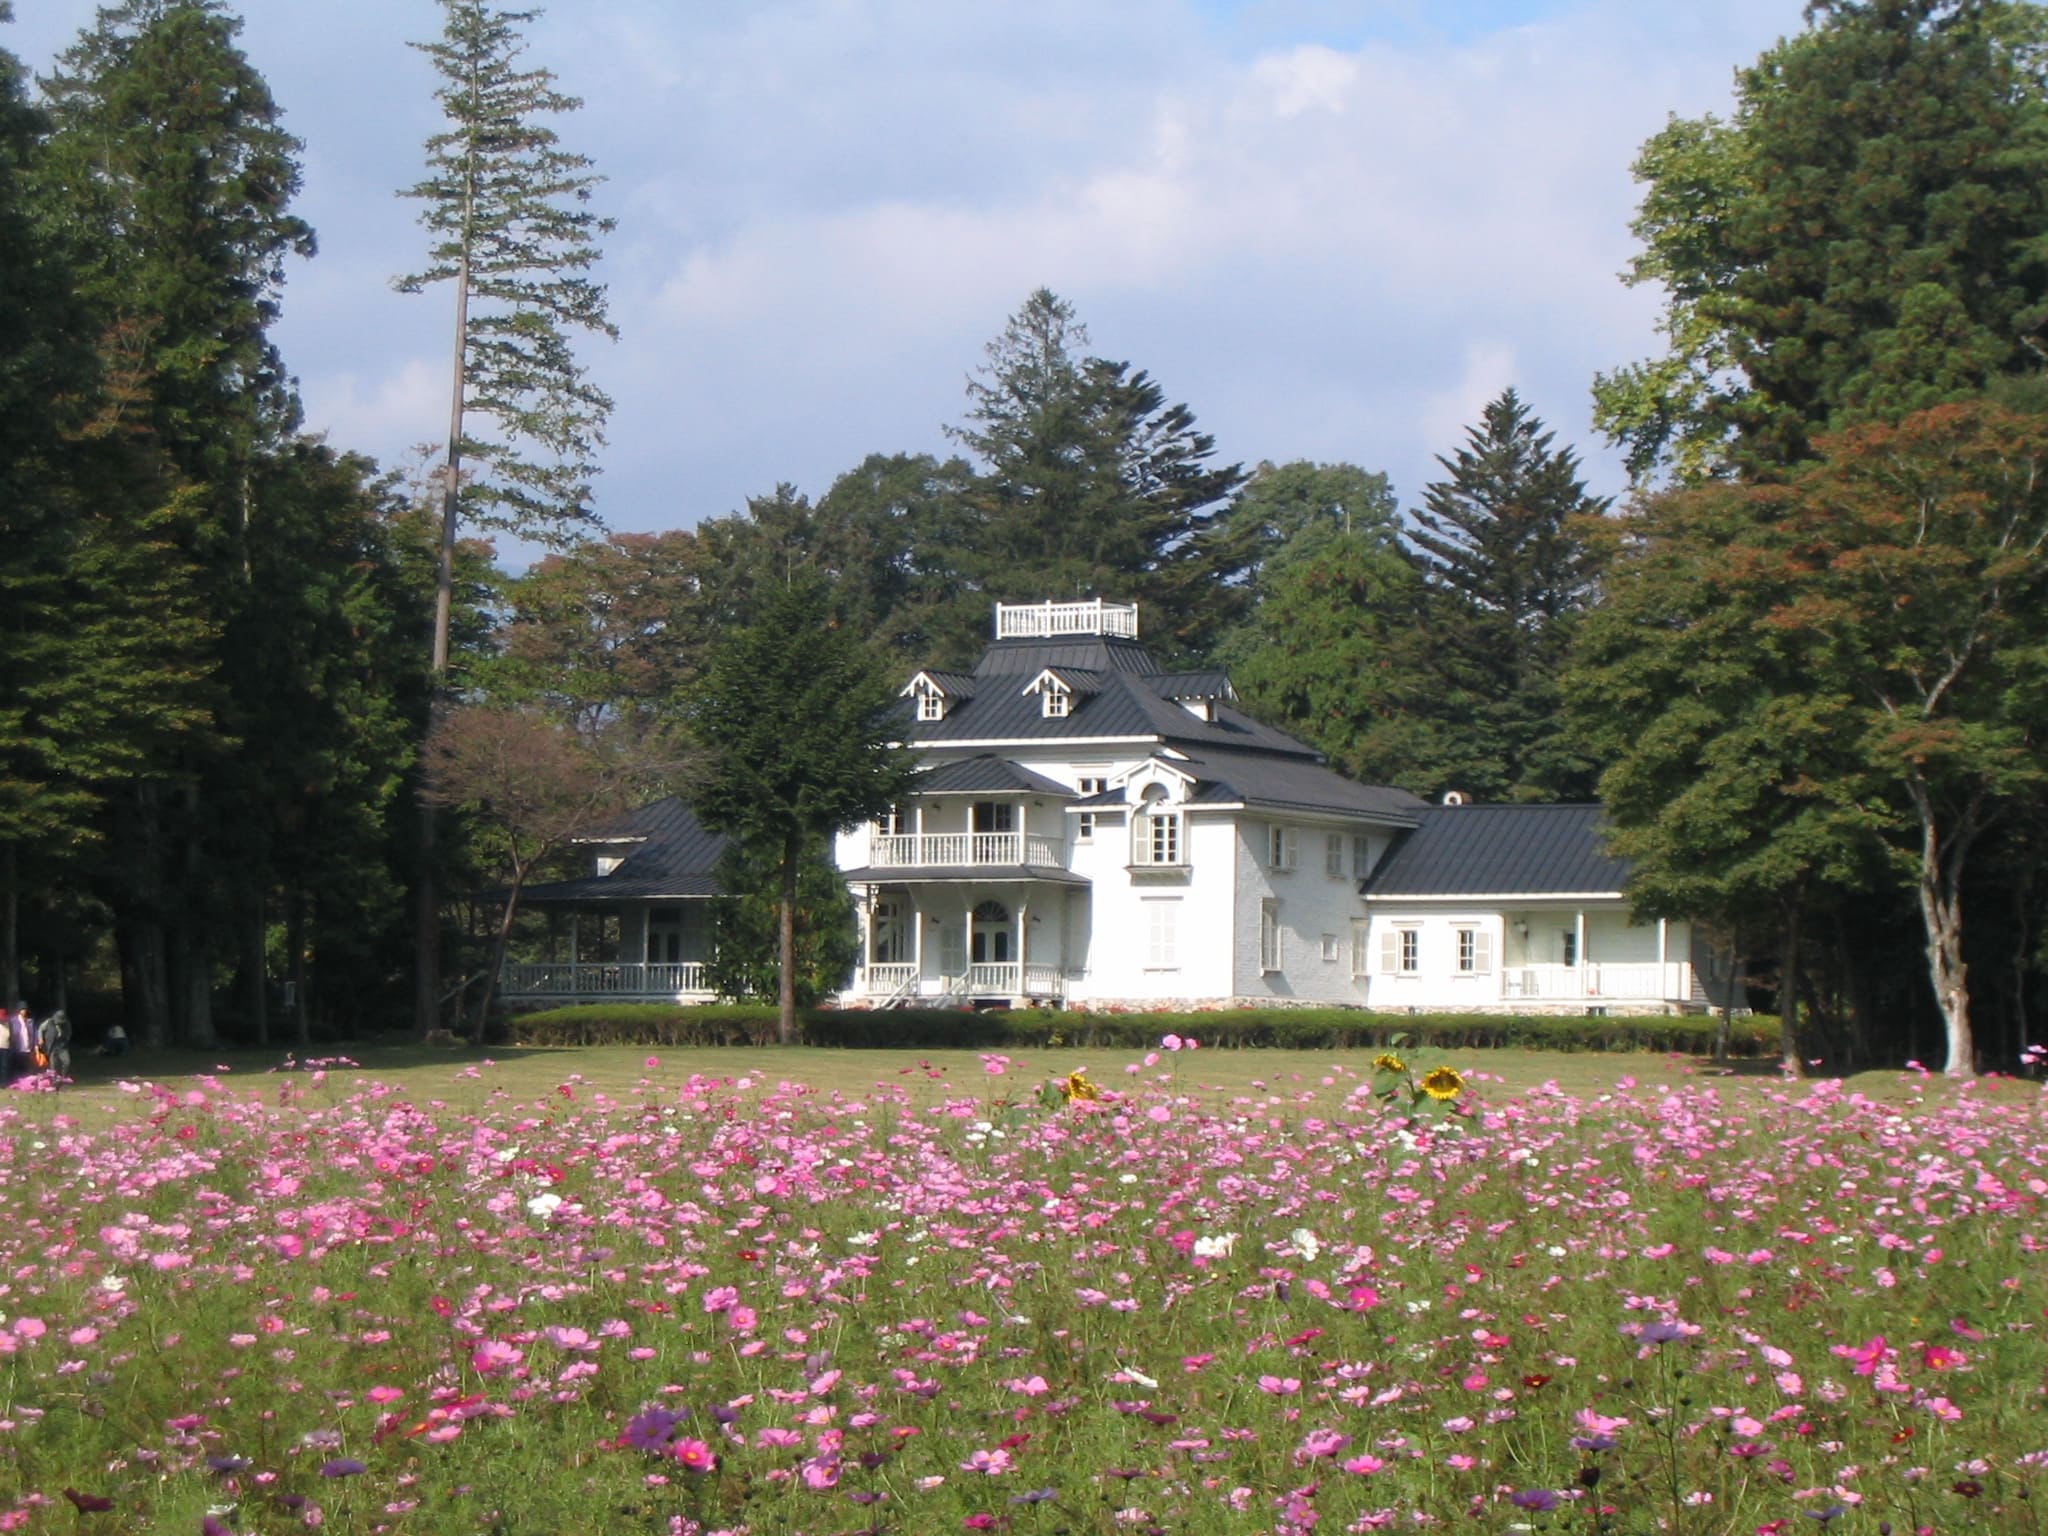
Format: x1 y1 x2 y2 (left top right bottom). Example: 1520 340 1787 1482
1364 805 1628 899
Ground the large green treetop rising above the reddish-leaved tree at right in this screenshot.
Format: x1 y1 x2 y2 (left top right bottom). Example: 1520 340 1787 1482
1593 0 2048 479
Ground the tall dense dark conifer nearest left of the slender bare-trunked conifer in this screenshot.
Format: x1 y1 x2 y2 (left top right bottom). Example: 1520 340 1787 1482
37 0 313 1044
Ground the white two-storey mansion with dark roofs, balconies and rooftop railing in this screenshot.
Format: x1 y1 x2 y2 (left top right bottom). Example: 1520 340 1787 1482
504 602 1718 1012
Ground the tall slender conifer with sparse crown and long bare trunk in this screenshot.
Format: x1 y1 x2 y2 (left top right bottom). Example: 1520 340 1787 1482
397 0 616 1032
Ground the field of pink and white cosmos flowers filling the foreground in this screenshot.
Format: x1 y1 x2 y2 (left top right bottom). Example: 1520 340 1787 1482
0 1059 2048 1536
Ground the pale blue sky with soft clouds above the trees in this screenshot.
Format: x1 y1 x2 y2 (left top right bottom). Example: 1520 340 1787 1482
0 0 1800 552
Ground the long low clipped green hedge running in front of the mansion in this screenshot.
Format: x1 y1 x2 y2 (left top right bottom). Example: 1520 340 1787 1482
510 1004 1778 1057
